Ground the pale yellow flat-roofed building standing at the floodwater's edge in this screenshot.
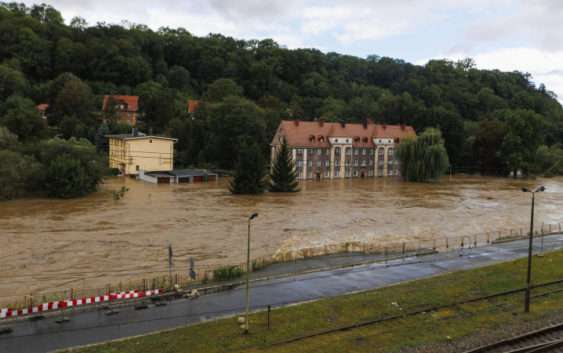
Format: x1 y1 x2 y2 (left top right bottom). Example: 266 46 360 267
107 132 178 175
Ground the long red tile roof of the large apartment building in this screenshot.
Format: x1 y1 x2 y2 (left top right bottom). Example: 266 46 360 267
272 120 416 148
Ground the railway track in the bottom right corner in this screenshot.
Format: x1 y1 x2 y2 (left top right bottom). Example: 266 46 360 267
464 322 563 353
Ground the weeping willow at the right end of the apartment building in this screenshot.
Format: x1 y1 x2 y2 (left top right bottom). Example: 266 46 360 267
397 128 450 182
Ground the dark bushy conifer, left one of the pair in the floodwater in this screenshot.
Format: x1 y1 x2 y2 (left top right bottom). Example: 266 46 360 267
229 140 266 194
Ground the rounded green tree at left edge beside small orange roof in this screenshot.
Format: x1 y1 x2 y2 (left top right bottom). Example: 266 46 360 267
0 96 45 141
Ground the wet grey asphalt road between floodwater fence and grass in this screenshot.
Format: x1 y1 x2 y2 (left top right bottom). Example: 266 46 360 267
0 235 563 353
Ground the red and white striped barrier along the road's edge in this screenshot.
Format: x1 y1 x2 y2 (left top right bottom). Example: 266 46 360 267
0 289 160 319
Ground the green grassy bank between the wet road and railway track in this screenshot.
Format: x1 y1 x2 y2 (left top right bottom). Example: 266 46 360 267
67 252 563 353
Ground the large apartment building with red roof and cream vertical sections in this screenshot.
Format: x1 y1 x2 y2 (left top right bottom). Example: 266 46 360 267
271 120 416 179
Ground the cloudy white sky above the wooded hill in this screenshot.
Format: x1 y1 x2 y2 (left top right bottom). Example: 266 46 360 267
24 0 563 100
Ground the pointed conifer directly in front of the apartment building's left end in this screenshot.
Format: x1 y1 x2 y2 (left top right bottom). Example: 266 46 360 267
270 139 299 192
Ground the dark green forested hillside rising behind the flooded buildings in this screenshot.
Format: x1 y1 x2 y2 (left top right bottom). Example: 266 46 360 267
0 3 563 179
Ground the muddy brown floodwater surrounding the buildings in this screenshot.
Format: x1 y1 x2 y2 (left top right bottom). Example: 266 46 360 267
0 176 563 301
